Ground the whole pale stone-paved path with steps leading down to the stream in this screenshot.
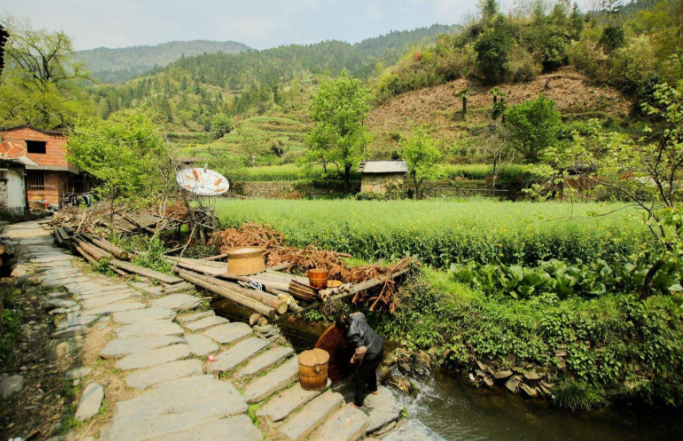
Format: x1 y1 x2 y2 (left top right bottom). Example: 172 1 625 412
2 222 440 441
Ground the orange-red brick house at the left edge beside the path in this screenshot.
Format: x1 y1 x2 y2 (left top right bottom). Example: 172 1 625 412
0 125 90 207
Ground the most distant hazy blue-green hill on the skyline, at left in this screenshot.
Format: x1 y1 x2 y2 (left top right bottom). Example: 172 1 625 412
76 40 250 83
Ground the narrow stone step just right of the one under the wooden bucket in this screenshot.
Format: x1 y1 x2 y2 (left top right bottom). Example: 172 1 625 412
278 391 344 441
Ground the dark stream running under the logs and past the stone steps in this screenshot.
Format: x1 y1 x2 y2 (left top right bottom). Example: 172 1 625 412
212 300 683 441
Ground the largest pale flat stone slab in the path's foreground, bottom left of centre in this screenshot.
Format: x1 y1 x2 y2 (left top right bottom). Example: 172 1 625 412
105 375 247 441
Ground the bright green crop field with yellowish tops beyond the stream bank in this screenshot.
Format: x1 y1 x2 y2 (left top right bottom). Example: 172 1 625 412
216 199 650 267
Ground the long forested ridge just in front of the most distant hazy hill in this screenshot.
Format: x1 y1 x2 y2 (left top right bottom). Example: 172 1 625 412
159 24 459 90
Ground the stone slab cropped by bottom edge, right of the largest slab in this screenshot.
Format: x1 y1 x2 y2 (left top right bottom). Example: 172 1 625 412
158 415 263 441
